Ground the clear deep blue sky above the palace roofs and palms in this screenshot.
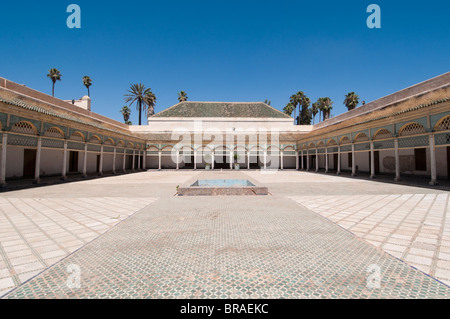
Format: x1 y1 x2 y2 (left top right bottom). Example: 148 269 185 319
0 0 450 124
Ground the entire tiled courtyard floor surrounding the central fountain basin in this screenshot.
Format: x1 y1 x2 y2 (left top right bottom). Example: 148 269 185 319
0 171 450 298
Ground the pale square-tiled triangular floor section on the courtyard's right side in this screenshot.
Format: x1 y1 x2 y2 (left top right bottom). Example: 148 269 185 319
291 192 450 284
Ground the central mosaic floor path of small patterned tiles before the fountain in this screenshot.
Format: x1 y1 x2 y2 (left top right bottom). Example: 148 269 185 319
6 196 450 298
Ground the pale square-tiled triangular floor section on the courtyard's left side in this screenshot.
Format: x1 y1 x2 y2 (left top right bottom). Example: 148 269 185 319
0 196 155 296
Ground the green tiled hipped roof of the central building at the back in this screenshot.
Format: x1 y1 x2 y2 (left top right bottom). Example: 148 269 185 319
152 102 290 119
